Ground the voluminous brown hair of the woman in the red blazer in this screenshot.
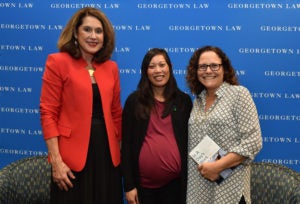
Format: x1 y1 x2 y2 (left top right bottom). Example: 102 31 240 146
57 7 115 62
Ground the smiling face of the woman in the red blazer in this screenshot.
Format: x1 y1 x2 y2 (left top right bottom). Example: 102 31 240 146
75 16 104 60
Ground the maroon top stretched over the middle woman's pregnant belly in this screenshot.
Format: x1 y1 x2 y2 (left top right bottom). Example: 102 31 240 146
139 101 181 188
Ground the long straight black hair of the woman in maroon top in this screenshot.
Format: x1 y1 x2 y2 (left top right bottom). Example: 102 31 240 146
136 48 178 119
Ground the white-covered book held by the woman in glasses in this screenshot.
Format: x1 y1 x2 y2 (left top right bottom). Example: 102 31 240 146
189 136 234 183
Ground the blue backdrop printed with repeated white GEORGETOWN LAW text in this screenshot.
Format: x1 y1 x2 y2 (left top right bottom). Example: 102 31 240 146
0 0 300 171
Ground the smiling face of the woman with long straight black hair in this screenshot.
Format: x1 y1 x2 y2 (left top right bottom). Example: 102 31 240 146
147 55 170 88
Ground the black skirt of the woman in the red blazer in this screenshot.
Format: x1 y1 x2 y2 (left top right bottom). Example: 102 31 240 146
50 119 123 204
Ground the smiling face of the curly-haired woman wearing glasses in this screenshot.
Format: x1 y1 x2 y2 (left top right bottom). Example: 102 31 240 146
197 51 224 94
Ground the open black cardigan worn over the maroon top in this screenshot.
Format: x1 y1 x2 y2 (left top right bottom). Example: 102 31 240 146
121 90 192 203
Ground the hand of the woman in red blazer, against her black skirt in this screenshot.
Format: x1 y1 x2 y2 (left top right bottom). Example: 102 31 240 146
51 160 75 191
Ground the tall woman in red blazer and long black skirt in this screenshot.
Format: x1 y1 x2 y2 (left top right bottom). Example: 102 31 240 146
40 8 123 204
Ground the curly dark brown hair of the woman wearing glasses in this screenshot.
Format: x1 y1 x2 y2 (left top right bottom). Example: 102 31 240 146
186 46 239 95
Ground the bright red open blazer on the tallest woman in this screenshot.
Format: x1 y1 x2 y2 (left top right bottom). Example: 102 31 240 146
40 53 122 171
